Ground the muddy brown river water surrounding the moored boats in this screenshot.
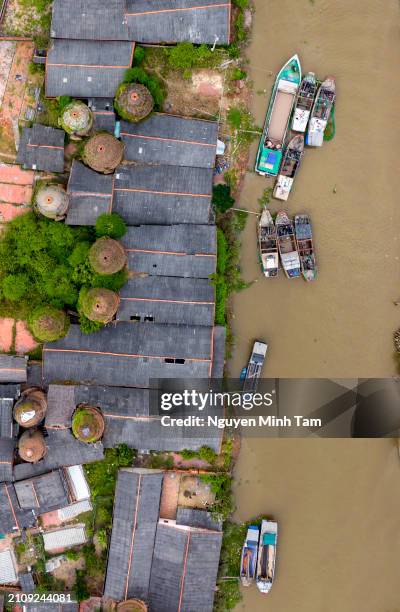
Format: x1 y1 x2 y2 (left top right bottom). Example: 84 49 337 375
230 0 400 612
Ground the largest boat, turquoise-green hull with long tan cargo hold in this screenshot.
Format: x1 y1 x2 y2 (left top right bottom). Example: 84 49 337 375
255 55 301 176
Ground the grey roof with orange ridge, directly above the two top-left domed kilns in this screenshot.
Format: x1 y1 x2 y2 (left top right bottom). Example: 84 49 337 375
46 38 135 98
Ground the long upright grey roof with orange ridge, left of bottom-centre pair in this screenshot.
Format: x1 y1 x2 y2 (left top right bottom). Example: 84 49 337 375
104 468 163 600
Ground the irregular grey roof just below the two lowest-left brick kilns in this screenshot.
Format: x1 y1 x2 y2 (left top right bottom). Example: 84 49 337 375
14 429 104 481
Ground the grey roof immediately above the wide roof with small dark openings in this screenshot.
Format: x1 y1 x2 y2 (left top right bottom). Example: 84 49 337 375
117 276 215 326
